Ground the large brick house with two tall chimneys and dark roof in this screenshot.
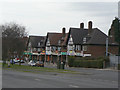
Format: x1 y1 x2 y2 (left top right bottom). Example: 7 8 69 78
67 21 108 57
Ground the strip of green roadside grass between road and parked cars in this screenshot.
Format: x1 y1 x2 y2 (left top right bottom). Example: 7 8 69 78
3 64 82 74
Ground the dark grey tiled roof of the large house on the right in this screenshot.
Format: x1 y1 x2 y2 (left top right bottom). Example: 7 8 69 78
69 28 108 45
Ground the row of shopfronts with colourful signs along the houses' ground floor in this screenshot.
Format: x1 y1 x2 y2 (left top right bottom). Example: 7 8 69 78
24 51 91 63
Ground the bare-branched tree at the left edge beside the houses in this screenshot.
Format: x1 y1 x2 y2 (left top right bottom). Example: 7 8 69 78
0 23 28 60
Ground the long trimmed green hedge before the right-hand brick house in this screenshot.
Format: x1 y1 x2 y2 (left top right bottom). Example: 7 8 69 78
68 56 109 68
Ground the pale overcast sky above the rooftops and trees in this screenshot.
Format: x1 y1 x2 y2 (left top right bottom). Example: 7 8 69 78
0 0 118 36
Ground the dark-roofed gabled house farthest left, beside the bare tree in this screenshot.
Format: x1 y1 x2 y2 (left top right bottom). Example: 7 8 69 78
27 36 46 60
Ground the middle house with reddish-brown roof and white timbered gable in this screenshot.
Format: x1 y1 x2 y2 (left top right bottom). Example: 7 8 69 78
45 28 67 63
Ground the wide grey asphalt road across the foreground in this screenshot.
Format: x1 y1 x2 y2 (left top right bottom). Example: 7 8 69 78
2 68 118 88
